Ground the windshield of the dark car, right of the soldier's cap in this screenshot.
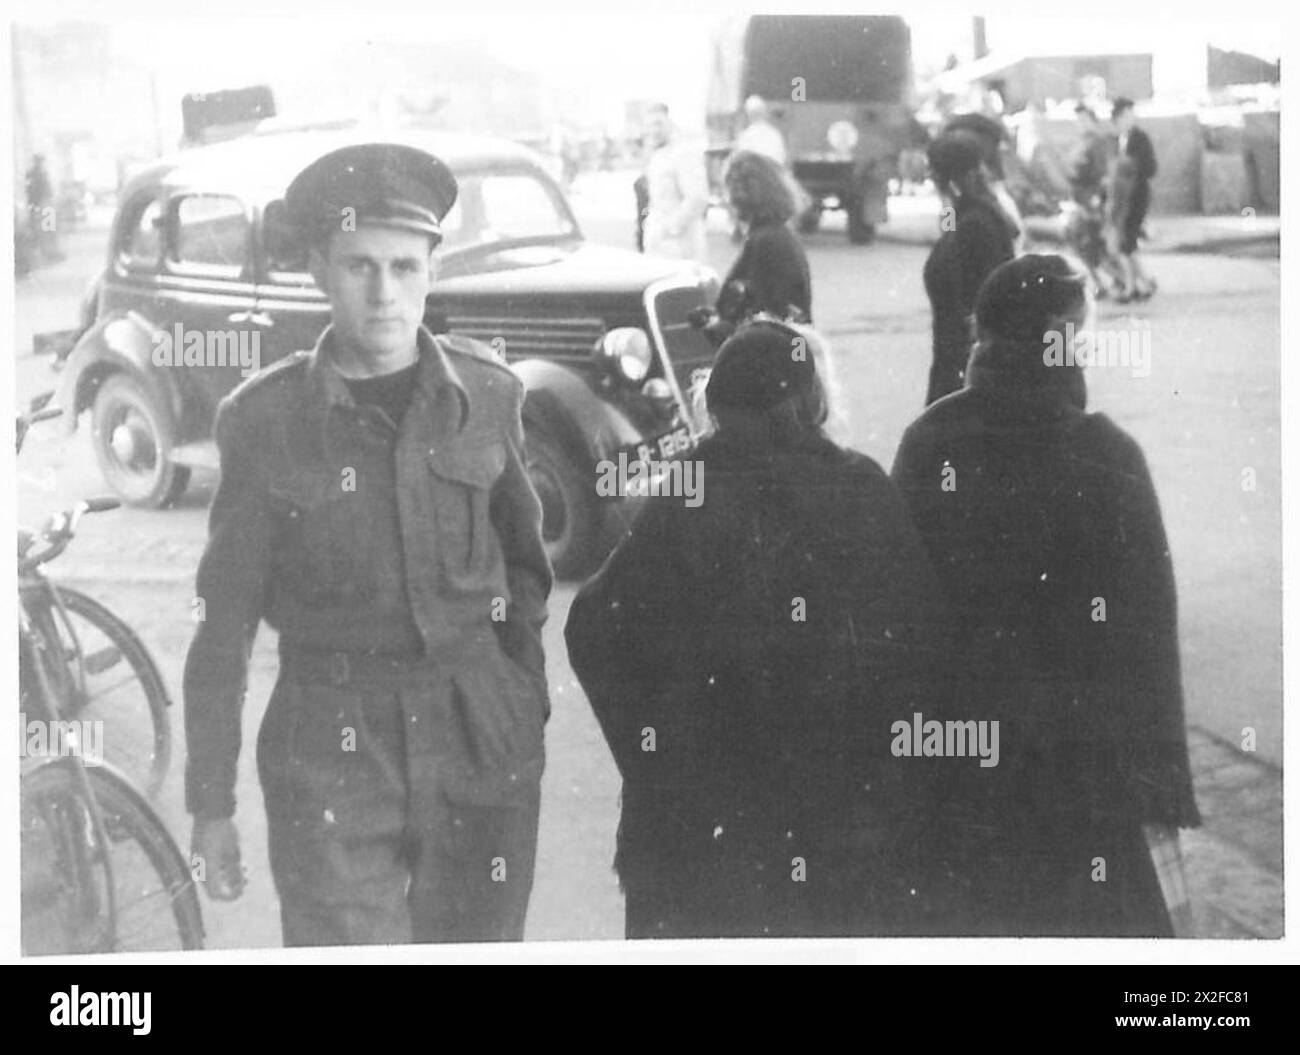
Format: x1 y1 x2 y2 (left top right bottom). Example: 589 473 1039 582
442 173 576 249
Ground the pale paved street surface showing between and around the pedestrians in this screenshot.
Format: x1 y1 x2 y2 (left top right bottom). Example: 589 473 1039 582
16 178 1282 947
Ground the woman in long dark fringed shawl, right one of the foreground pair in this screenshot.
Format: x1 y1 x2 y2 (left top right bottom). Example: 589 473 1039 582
893 256 1199 935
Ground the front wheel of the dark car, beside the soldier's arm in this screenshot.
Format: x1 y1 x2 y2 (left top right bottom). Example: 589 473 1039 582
525 430 601 578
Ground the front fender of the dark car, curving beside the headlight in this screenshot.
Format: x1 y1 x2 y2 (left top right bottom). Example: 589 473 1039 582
511 359 645 470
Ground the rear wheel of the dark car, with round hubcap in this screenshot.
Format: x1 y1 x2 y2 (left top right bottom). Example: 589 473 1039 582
91 374 190 509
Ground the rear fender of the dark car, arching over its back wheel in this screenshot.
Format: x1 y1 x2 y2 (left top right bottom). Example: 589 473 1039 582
55 312 183 440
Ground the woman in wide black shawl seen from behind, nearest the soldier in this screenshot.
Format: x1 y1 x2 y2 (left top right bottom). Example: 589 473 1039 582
566 321 946 938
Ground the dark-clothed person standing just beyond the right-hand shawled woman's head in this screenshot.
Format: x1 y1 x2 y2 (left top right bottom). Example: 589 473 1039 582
923 131 1017 407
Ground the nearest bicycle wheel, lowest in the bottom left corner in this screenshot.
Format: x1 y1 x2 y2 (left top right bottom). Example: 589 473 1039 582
21 764 203 955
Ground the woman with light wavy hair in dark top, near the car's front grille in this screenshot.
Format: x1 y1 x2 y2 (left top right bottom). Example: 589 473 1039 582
699 151 813 346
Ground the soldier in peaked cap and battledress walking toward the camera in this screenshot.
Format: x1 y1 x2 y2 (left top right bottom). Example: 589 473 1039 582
185 144 551 945
